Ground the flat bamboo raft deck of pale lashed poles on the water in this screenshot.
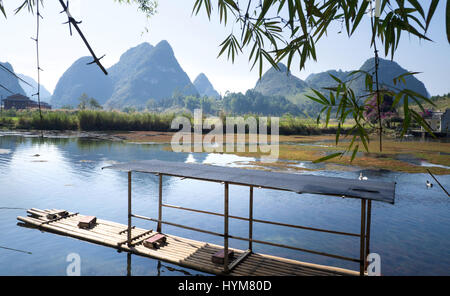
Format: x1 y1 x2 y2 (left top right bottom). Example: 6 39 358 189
17 208 359 276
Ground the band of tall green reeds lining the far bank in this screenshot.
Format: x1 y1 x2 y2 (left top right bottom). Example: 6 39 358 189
0 110 336 135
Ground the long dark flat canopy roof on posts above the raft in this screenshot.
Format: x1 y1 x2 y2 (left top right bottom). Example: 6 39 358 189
104 159 395 204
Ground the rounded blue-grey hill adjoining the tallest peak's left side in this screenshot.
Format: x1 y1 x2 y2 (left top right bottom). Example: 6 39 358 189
51 57 113 108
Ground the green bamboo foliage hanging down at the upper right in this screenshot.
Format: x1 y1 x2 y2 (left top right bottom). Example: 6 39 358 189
193 0 450 161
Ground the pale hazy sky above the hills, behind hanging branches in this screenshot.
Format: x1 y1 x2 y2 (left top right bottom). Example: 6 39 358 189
0 0 450 95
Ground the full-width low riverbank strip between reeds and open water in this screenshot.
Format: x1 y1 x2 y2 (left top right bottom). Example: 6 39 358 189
0 131 450 175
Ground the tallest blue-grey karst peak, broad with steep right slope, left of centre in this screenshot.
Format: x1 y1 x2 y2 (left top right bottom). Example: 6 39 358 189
105 40 198 108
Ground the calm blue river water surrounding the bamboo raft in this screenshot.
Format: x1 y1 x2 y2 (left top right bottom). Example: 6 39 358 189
0 135 450 275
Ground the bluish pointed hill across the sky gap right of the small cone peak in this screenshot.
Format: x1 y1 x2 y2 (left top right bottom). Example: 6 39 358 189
253 63 308 97
